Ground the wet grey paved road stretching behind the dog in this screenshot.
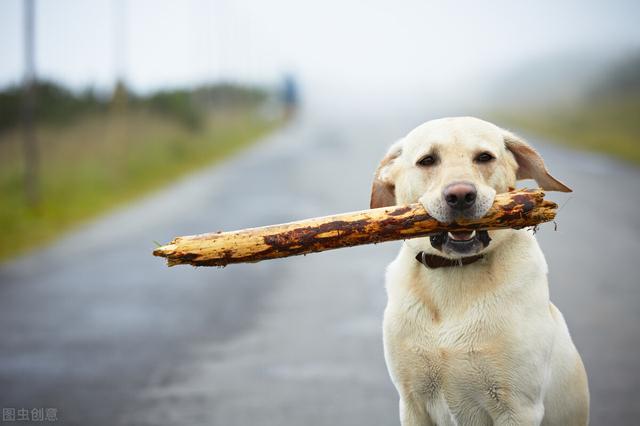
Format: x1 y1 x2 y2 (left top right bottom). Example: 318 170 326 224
0 111 640 426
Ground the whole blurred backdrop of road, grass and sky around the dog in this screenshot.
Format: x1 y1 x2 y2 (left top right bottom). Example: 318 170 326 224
0 0 640 425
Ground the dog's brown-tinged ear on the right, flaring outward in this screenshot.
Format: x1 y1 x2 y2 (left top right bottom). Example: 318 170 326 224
504 130 572 192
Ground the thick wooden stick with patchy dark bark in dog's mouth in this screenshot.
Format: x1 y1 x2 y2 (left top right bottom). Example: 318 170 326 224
153 190 557 266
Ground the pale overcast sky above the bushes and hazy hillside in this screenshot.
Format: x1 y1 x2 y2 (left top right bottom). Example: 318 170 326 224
0 0 640 103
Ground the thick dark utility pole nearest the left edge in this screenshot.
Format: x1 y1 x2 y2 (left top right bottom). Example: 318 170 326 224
22 0 40 208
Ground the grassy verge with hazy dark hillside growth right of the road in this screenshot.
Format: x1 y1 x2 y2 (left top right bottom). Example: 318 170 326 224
498 51 640 164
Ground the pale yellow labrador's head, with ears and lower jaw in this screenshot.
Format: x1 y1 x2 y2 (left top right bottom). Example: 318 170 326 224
371 117 571 258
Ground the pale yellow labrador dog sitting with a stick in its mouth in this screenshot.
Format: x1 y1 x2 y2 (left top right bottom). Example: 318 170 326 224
371 117 589 426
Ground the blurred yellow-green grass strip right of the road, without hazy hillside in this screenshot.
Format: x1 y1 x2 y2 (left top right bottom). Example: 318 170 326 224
493 97 640 165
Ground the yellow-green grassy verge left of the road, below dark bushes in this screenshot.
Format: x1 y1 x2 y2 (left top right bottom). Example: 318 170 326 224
0 109 280 259
